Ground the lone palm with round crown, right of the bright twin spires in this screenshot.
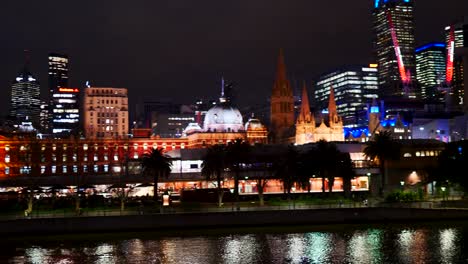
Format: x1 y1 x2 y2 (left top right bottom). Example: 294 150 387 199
364 130 400 195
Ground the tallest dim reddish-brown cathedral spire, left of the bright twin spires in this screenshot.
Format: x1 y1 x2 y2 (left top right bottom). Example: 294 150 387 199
270 50 294 143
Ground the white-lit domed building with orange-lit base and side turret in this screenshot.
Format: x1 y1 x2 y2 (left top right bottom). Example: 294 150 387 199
185 80 267 148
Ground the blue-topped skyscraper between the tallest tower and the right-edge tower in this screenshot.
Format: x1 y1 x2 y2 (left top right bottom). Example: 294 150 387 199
416 42 446 101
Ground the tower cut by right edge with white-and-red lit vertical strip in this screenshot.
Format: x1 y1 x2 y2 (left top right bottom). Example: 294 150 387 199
445 16 468 108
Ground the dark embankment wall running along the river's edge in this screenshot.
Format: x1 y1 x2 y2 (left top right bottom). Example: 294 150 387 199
0 207 468 235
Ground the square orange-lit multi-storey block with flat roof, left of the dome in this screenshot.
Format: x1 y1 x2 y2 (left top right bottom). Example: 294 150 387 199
83 87 129 138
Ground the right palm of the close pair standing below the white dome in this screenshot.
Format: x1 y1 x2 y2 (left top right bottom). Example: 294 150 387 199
226 138 251 210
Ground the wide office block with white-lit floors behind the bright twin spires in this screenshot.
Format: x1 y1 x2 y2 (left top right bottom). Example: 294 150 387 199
314 65 378 127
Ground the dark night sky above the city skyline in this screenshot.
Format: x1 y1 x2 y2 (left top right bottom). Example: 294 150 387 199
0 0 468 120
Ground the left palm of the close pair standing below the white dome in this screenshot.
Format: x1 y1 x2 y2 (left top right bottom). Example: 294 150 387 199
201 145 226 207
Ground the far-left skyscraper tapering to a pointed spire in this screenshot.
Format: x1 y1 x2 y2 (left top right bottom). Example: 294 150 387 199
10 51 41 129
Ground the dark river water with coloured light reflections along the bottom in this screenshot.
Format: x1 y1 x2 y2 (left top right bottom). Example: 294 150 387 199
0 222 468 263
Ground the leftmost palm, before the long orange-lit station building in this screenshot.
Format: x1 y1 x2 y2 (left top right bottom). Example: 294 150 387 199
141 148 172 201
